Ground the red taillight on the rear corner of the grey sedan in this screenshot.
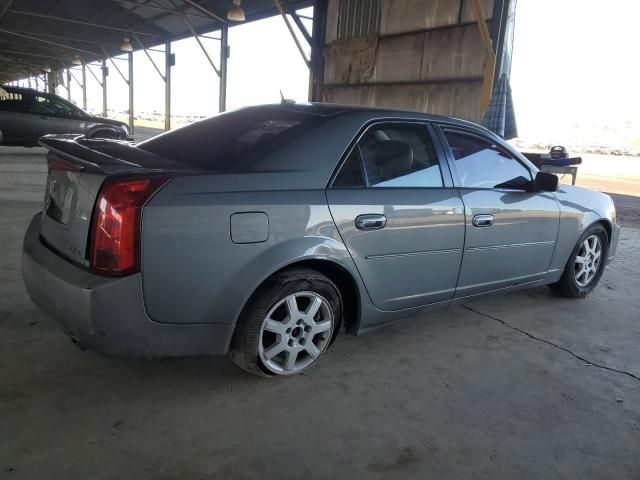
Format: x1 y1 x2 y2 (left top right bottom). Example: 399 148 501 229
89 175 171 276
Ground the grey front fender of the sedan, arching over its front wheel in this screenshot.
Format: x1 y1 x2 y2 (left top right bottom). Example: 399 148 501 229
549 184 616 280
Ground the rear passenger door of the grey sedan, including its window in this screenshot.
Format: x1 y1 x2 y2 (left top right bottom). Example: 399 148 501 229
327 121 464 310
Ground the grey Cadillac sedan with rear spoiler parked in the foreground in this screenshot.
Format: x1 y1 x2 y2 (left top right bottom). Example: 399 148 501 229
22 104 619 376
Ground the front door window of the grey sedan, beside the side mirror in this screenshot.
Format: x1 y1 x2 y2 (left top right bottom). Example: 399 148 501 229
444 131 531 190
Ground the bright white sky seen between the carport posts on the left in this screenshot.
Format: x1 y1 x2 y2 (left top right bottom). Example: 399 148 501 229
68 8 313 115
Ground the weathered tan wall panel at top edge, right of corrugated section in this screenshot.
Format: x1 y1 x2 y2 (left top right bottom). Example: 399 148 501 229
380 0 460 35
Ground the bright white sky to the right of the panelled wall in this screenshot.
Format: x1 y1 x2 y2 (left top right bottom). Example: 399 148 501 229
511 0 640 143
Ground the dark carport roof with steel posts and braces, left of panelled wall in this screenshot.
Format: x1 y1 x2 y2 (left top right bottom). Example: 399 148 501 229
0 0 318 129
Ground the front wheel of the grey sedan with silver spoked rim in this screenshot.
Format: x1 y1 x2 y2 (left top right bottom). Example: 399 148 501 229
549 223 609 298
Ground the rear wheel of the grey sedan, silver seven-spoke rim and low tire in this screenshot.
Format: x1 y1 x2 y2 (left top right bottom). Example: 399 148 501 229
230 268 342 377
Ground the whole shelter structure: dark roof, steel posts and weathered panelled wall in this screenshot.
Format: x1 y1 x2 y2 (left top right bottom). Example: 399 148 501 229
0 0 516 134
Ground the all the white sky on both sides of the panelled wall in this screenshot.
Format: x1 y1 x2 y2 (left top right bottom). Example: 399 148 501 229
46 0 640 142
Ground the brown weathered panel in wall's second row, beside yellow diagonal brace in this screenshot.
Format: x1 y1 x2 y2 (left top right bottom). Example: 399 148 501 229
420 25 486 80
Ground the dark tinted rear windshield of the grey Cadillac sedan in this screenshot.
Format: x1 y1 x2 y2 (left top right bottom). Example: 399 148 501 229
139 107 323 172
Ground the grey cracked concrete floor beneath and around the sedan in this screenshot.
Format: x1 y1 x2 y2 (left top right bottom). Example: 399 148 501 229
0 144 640 480
